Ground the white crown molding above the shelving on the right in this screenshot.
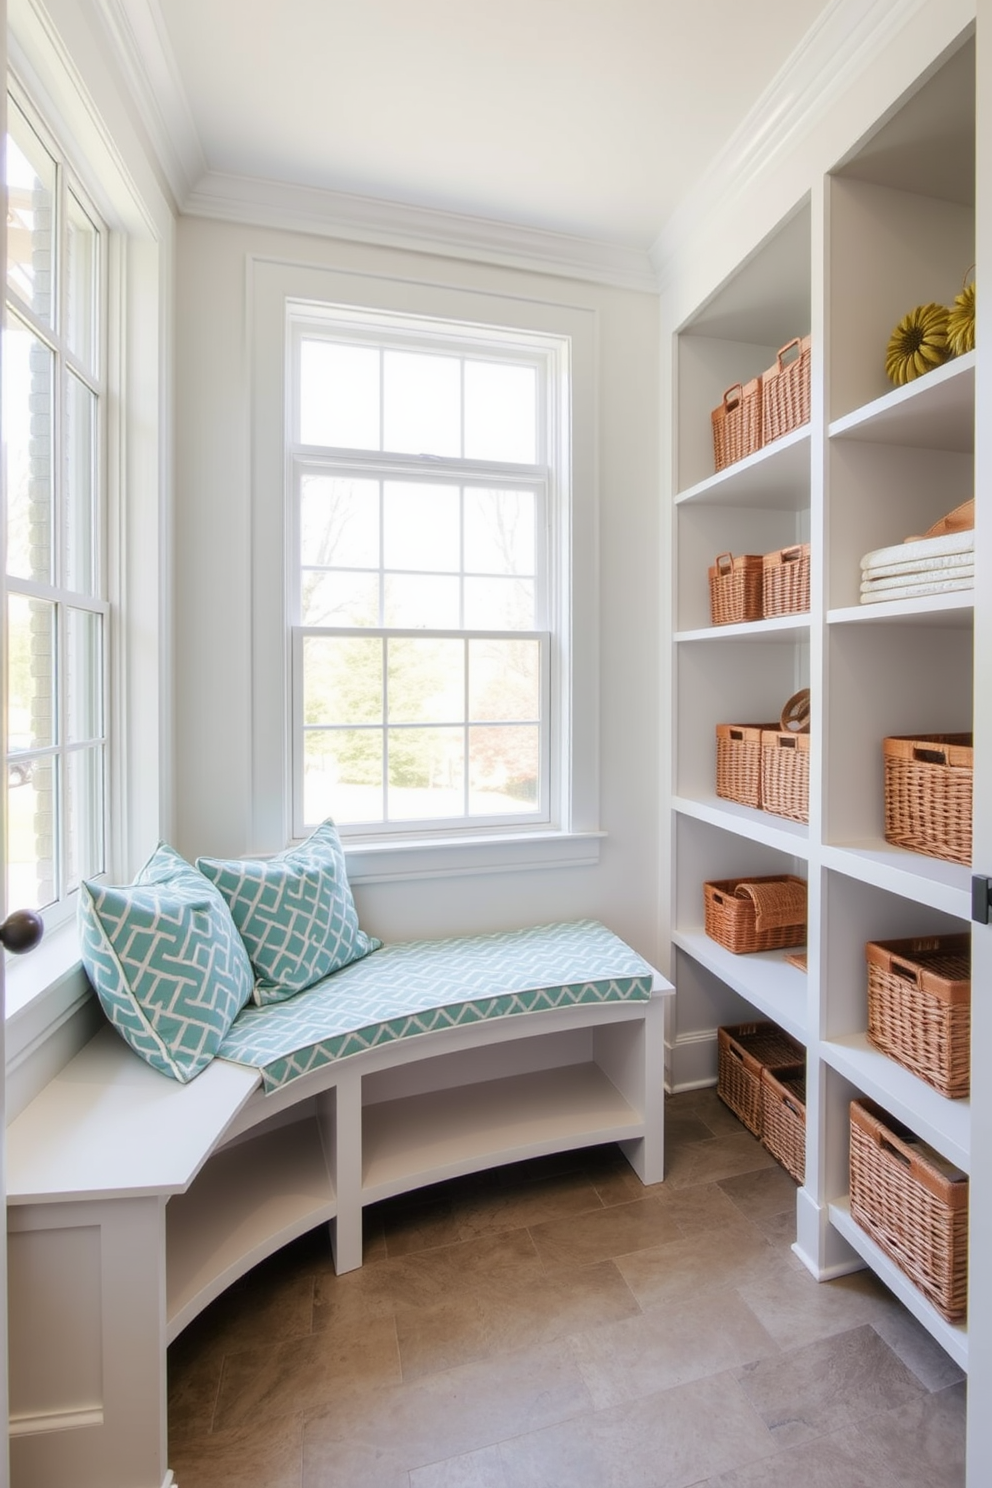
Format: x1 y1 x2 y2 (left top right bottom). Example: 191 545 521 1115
650 0 943 290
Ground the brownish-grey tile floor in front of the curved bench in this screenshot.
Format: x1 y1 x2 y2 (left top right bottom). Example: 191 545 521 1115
170 1091 964 1488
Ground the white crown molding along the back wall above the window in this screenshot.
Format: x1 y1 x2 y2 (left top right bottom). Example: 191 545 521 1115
183 171 657 295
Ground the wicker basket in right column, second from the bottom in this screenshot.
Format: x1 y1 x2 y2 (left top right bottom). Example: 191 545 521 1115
866 934 971 1100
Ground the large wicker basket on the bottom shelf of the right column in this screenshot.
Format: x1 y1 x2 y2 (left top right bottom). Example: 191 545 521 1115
851 1100 968 1323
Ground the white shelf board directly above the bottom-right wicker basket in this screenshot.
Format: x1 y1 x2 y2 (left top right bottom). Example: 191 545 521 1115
821 1033 971 1173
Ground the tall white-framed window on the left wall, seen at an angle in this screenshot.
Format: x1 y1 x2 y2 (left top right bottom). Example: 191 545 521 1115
3 90 107 918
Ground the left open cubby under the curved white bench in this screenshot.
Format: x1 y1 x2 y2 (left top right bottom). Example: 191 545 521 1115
165 1120 336 1342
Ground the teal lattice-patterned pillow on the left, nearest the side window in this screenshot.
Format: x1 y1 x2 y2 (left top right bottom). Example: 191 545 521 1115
79 844 251 1083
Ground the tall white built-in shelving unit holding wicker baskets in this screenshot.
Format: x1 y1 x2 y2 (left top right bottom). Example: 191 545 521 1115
671 23 992 1416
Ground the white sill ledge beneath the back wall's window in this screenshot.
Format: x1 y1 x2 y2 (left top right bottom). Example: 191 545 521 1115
342 832 605 887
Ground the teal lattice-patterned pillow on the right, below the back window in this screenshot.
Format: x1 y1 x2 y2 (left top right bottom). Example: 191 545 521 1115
196 821 382 1007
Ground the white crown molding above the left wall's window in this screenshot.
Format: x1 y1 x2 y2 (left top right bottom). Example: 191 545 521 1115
94 0 207 208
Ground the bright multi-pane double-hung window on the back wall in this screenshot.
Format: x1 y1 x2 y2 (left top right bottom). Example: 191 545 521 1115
289 304 568 836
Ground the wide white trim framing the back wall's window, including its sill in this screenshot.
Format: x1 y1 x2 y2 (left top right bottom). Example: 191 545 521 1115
252 256 602 882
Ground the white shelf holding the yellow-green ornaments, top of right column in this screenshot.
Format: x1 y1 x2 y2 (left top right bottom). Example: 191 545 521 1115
830 351 976 454
